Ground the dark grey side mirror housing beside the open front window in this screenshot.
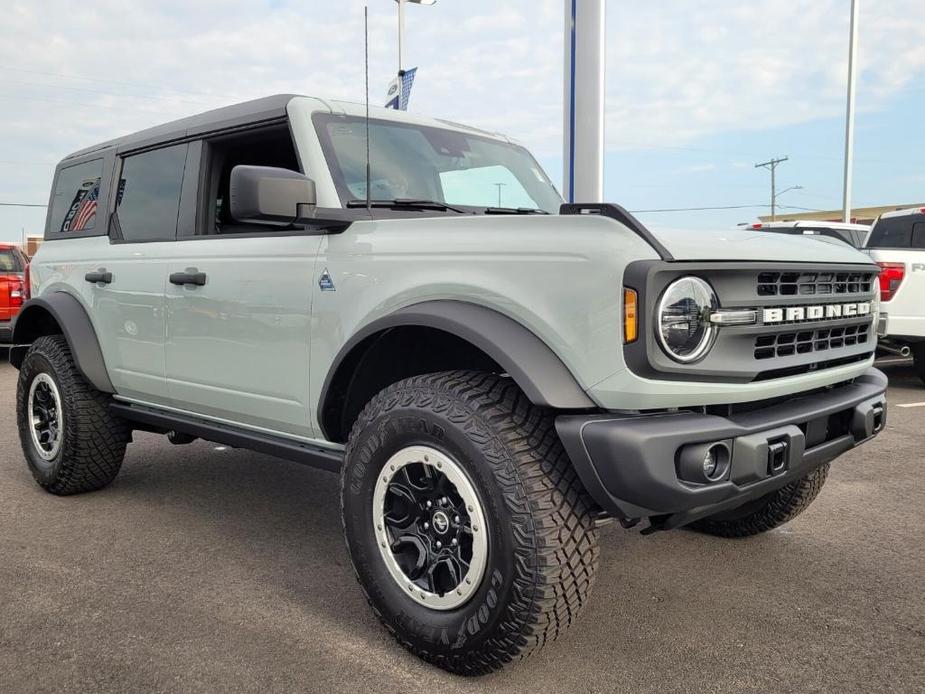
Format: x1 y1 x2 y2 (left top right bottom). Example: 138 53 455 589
229 164 317 224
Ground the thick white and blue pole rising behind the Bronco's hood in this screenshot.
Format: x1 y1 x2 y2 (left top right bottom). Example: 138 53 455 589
563 0 606 202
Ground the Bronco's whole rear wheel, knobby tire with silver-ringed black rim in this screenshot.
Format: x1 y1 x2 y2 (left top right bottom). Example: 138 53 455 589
16 335 130 495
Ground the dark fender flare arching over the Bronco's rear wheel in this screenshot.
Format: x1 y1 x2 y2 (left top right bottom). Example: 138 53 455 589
10 291 115 393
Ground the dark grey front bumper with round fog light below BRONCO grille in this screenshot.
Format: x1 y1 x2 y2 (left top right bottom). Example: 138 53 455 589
556 369 887 529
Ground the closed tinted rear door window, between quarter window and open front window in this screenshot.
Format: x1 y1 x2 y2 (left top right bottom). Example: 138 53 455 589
116 144 188 241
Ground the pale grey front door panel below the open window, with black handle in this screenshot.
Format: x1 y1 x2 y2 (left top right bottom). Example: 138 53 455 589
166 237 322 436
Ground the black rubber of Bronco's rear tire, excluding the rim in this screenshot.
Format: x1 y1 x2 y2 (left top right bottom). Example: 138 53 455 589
16 335 131 496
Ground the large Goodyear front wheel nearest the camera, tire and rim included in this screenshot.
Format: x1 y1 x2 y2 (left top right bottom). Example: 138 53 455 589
341 371 598 675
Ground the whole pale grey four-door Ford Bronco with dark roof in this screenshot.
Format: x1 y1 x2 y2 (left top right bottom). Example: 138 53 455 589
11 96 886 674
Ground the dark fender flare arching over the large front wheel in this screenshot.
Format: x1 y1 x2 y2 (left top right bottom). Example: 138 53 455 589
318 300 597 432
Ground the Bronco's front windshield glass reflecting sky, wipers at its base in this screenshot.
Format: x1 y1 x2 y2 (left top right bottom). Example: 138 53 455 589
314 114 562 214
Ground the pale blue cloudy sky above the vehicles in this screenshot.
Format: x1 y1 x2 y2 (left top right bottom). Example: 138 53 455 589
0 0 925 240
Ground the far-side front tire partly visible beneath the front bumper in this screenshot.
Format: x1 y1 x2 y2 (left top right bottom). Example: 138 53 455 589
690 463 829 537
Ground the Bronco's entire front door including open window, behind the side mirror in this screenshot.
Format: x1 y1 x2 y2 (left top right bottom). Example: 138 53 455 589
166 123 323 437
